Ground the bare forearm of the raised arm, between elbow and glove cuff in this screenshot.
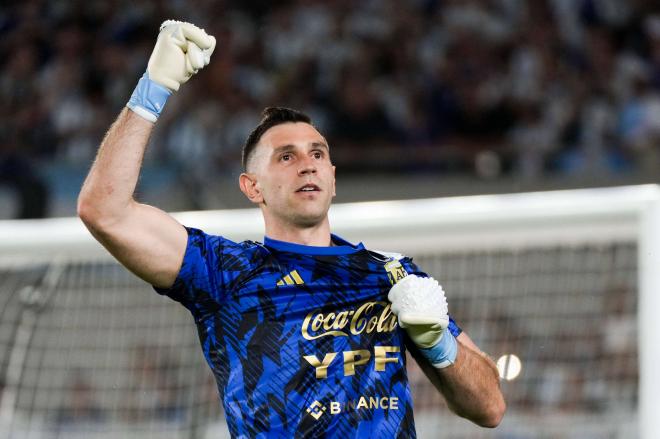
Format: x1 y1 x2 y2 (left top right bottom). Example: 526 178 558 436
78 108 154 221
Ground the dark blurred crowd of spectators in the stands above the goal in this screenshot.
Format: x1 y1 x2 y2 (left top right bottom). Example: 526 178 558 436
0 0 660 216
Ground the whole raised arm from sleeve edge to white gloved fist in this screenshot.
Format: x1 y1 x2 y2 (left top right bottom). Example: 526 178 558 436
78 21 215 287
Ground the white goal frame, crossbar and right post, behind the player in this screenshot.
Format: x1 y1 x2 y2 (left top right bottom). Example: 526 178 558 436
0 185 660 439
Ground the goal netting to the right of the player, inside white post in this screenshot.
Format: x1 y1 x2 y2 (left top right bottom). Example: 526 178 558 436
410 243 638 438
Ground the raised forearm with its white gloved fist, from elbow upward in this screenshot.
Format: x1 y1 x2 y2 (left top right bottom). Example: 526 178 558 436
78 20 215 228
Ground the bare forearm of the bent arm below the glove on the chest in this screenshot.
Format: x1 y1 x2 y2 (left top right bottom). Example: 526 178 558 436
436 337 505 427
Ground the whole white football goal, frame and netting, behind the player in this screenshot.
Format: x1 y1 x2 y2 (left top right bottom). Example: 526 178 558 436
0 186 660 439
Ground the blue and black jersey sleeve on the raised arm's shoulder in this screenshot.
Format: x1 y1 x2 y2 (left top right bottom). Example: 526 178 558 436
154 227 234 319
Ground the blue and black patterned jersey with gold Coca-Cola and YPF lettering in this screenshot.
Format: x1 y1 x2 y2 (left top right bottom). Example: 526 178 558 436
157 229 460 438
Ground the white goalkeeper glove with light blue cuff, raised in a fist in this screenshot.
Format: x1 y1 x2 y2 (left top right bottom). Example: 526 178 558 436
126 20 215 122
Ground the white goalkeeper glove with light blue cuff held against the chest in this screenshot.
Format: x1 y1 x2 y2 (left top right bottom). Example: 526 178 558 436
387 274 458 369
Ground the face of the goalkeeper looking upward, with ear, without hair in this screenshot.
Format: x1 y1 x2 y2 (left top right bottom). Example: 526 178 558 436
241 122 335 227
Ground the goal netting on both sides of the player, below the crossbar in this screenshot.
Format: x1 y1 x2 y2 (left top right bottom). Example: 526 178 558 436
0 242 638 439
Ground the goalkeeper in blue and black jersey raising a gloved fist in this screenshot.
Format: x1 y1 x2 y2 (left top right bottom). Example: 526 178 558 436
78 21 504 438
